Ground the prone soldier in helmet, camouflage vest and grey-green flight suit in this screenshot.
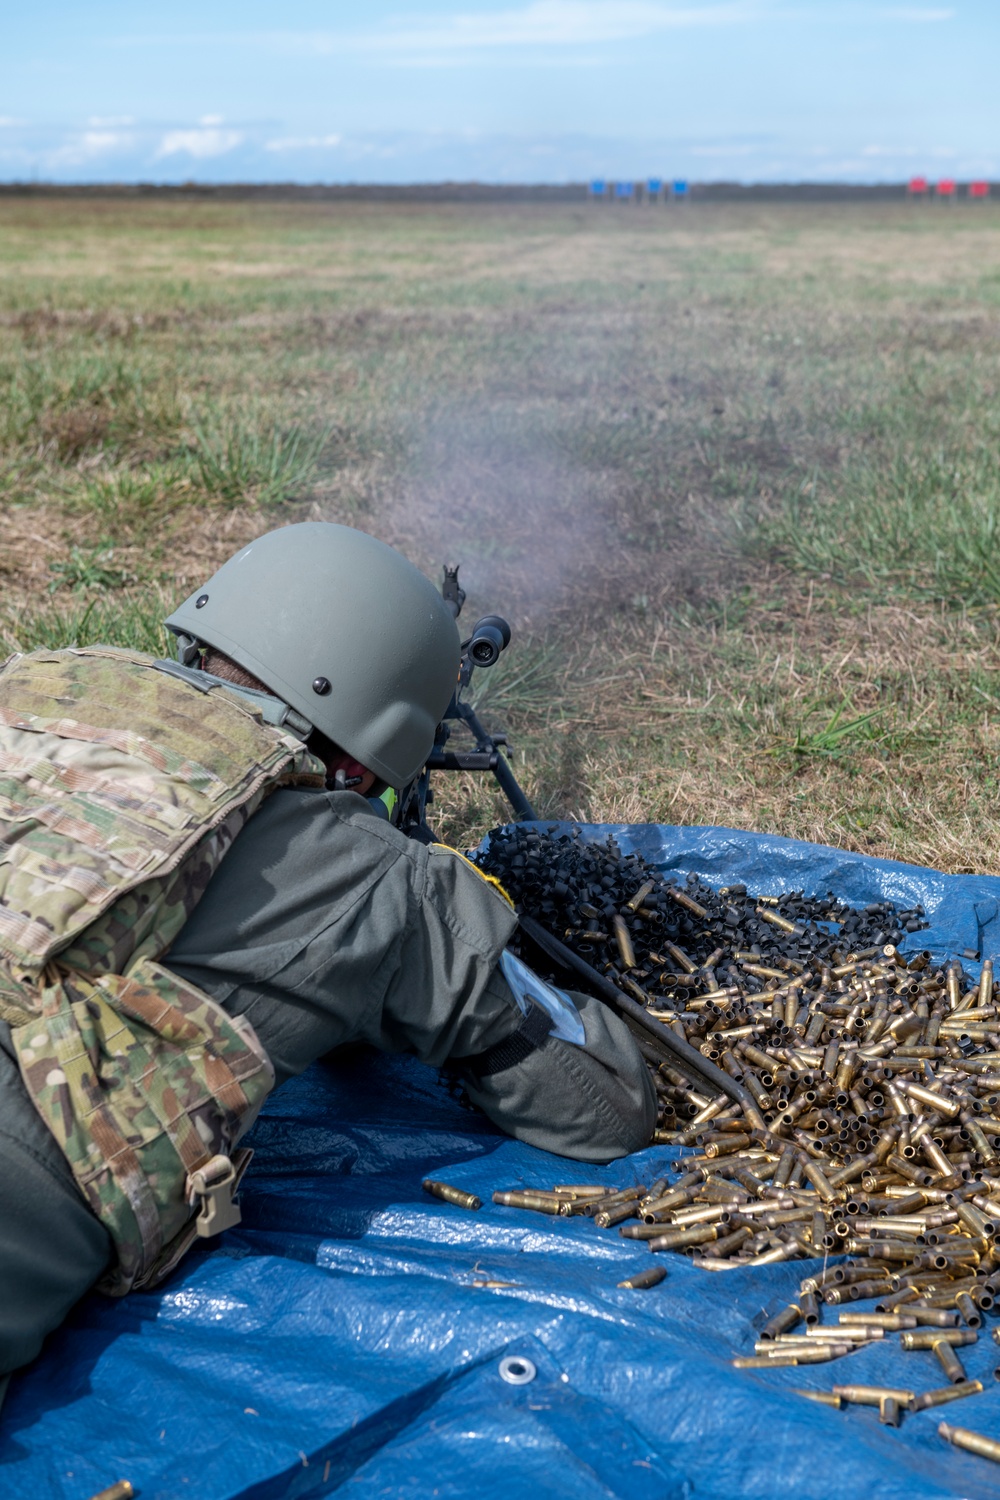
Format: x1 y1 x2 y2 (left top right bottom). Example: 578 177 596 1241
0 522 655 1388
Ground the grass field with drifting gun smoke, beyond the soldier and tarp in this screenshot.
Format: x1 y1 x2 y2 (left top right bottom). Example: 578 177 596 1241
0 198 1000 873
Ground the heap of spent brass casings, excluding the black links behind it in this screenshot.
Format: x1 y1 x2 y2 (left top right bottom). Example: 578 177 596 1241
501 947 1000 1302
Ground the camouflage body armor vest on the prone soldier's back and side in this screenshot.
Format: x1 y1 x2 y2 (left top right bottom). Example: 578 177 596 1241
0 647 324 1296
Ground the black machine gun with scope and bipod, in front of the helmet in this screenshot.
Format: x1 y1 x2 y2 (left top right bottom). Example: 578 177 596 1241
399 563 537 843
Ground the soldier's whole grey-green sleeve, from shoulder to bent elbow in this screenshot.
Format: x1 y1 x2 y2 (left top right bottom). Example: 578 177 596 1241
166 789 654 1161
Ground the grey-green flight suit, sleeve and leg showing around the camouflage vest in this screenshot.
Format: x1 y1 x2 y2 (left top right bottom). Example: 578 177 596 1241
0 788 655 1380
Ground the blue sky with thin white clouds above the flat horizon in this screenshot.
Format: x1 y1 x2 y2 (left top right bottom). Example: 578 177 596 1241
0 0 1000 183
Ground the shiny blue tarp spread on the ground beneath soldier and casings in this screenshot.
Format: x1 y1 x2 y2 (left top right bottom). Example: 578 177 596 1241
0 825 1000 1500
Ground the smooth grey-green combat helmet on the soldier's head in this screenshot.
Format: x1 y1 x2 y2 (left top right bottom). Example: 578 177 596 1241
165 521 460 788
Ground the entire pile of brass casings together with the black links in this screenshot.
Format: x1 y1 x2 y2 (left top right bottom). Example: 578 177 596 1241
484 830 1000 1457
